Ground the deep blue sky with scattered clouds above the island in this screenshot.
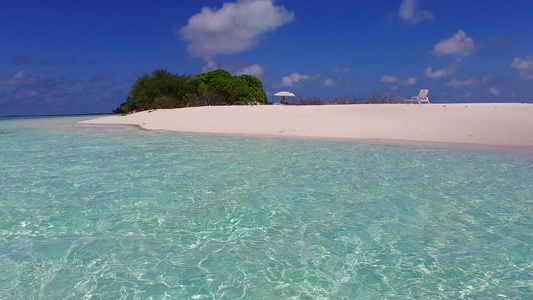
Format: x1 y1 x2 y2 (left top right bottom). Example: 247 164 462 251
0 0 533 115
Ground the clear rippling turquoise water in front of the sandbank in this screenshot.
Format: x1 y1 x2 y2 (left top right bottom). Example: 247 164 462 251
0 118 533 299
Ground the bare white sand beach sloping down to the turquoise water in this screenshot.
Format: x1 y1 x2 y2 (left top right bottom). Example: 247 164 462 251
80 103 533 148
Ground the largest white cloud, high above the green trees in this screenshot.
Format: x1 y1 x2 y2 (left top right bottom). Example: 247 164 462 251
179 0 294 59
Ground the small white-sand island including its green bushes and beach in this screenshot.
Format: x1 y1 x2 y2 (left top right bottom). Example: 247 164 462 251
87 70 533 150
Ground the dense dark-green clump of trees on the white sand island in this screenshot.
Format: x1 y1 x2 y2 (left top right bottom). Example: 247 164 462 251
113 70 268 114
